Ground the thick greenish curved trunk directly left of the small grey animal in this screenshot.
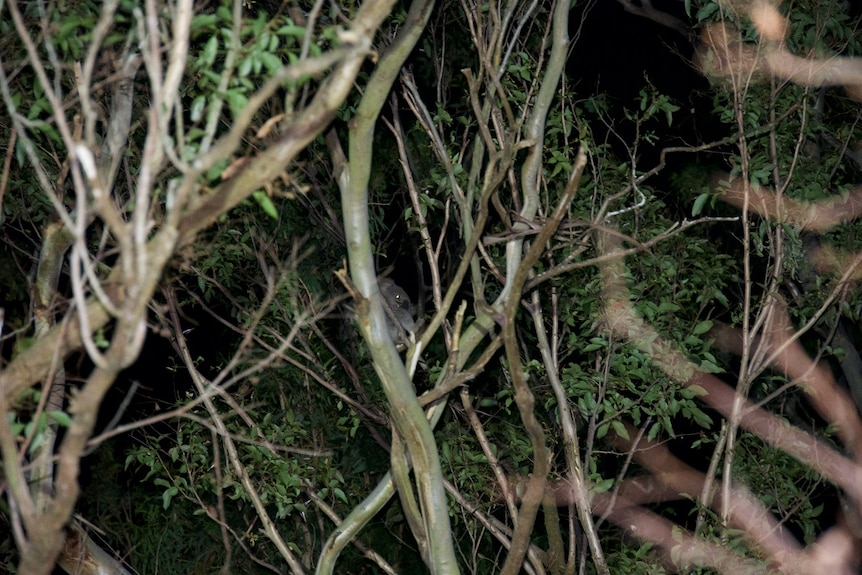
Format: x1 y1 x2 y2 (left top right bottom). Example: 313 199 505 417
330 0 458 575
